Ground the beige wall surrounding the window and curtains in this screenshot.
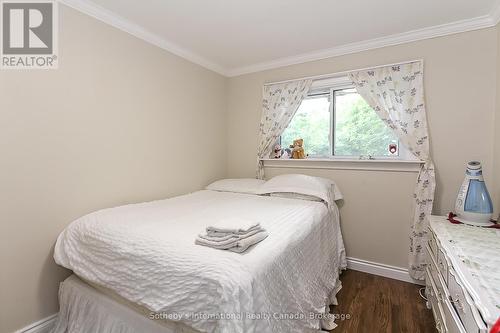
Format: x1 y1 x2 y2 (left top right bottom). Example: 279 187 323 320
228 28 497 267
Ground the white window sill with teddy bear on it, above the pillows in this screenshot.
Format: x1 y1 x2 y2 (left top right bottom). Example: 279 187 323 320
262 158 424 173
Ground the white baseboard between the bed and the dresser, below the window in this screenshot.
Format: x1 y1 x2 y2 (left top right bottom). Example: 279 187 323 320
347 258 425 285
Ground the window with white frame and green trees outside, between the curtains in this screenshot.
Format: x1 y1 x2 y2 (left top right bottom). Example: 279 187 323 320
281 78 411 159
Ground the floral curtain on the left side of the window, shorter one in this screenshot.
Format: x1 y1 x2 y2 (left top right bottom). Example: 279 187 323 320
257 79 312 179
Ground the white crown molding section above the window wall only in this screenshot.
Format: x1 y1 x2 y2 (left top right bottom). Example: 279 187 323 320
227 13 500 77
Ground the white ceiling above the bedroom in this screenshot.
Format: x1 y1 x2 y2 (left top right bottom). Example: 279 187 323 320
62 0 500 75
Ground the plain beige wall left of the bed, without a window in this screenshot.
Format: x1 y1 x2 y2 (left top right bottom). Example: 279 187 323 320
0 6 226 333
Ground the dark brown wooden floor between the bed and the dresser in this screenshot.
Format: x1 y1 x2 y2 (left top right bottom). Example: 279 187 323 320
331 270 437 333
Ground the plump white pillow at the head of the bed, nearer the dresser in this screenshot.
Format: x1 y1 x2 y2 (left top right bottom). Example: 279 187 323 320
257 174 343 207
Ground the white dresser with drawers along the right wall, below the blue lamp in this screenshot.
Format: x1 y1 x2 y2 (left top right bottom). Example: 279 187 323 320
425 216 500 333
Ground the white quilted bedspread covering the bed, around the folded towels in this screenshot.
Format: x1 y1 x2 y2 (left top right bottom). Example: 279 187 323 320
54 191 346 333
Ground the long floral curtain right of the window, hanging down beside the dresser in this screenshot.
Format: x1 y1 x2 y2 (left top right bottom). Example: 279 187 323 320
349 61 436 280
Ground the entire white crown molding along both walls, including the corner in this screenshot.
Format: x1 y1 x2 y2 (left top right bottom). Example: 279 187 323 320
58 0 500 77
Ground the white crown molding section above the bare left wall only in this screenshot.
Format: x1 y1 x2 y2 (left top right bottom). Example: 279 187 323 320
58 0 227 76
